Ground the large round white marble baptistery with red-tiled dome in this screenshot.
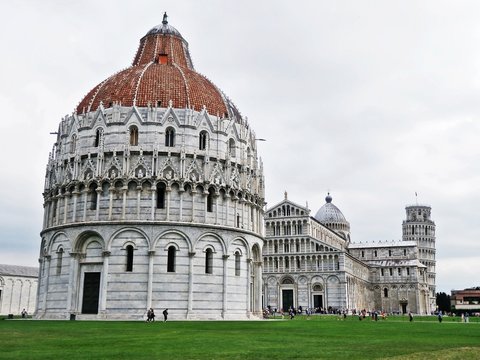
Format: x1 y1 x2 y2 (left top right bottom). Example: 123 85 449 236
36 14 265 319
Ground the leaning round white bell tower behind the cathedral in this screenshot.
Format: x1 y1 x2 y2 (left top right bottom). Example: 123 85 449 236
402 204 436 310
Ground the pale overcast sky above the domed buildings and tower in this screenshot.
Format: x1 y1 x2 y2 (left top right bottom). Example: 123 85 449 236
0 0 480 292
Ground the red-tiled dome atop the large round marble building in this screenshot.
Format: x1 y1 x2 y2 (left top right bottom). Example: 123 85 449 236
76 15 240 117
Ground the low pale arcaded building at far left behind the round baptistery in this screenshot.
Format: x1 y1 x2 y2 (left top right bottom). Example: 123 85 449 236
0 264 38 315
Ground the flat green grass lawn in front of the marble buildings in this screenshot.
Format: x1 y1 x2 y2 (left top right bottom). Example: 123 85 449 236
0 315 480 359
